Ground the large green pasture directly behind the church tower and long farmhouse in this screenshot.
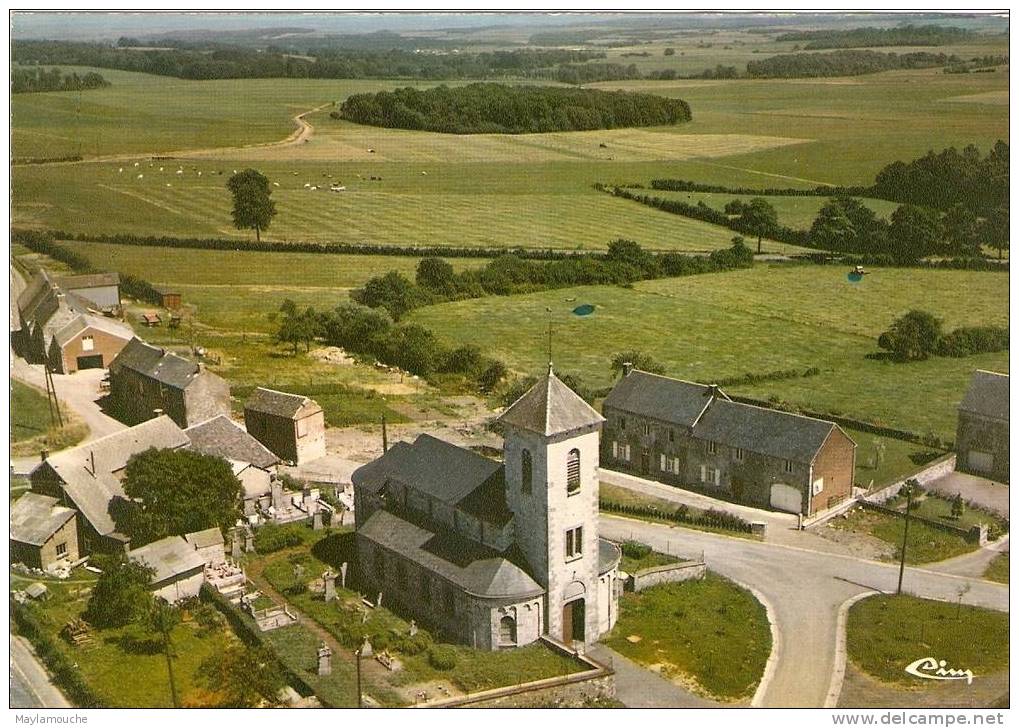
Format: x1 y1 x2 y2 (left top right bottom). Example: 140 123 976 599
412 265 1009 438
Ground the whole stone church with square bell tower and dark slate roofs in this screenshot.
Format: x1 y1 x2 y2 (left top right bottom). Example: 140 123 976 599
353 364 622 649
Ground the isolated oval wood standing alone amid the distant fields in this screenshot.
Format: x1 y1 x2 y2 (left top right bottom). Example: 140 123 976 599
332 84 690 134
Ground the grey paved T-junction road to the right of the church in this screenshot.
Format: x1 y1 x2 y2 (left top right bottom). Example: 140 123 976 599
599 509 1009 708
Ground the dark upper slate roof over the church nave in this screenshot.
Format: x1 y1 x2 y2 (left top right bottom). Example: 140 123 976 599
352 434 502 506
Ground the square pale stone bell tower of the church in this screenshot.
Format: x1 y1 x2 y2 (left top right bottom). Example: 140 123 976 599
499 364 604 643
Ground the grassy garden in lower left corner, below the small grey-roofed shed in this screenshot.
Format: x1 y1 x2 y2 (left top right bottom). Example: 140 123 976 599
11 570 236 708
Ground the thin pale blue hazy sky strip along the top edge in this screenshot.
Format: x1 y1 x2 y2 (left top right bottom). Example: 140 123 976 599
10 10 1007 41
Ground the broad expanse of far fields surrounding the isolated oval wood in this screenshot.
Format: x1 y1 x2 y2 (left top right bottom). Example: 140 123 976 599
12 60 1009 251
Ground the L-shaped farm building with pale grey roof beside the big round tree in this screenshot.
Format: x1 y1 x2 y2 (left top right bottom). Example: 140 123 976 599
29 416 189 554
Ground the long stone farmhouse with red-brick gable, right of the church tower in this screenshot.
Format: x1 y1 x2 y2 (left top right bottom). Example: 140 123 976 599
601 370 856 516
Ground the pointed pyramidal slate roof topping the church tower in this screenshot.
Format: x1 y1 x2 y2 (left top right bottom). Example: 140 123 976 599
498 366 605 436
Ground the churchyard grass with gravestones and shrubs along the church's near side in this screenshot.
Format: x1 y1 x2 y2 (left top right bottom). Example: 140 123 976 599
246 531 583 700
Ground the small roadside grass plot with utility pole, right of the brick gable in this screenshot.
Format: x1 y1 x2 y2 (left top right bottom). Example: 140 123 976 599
830 508 978 564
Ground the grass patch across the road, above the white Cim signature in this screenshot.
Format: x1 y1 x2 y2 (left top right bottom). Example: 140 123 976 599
846 594 1009 684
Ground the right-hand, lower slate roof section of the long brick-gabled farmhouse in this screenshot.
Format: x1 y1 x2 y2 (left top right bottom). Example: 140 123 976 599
693 393 837 463
